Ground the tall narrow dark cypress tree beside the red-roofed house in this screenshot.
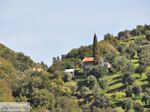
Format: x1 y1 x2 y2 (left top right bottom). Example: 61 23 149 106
93 34 100 65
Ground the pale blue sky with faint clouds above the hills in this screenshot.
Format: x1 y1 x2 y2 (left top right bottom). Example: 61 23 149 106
0 0 150 65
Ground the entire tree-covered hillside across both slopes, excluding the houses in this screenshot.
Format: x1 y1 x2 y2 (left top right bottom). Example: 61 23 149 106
0 25 150 112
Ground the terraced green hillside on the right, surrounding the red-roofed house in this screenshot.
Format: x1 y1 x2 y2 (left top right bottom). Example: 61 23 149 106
49 25 150 112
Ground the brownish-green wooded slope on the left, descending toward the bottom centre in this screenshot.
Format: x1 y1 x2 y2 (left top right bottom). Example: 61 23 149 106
0 44 81 112
